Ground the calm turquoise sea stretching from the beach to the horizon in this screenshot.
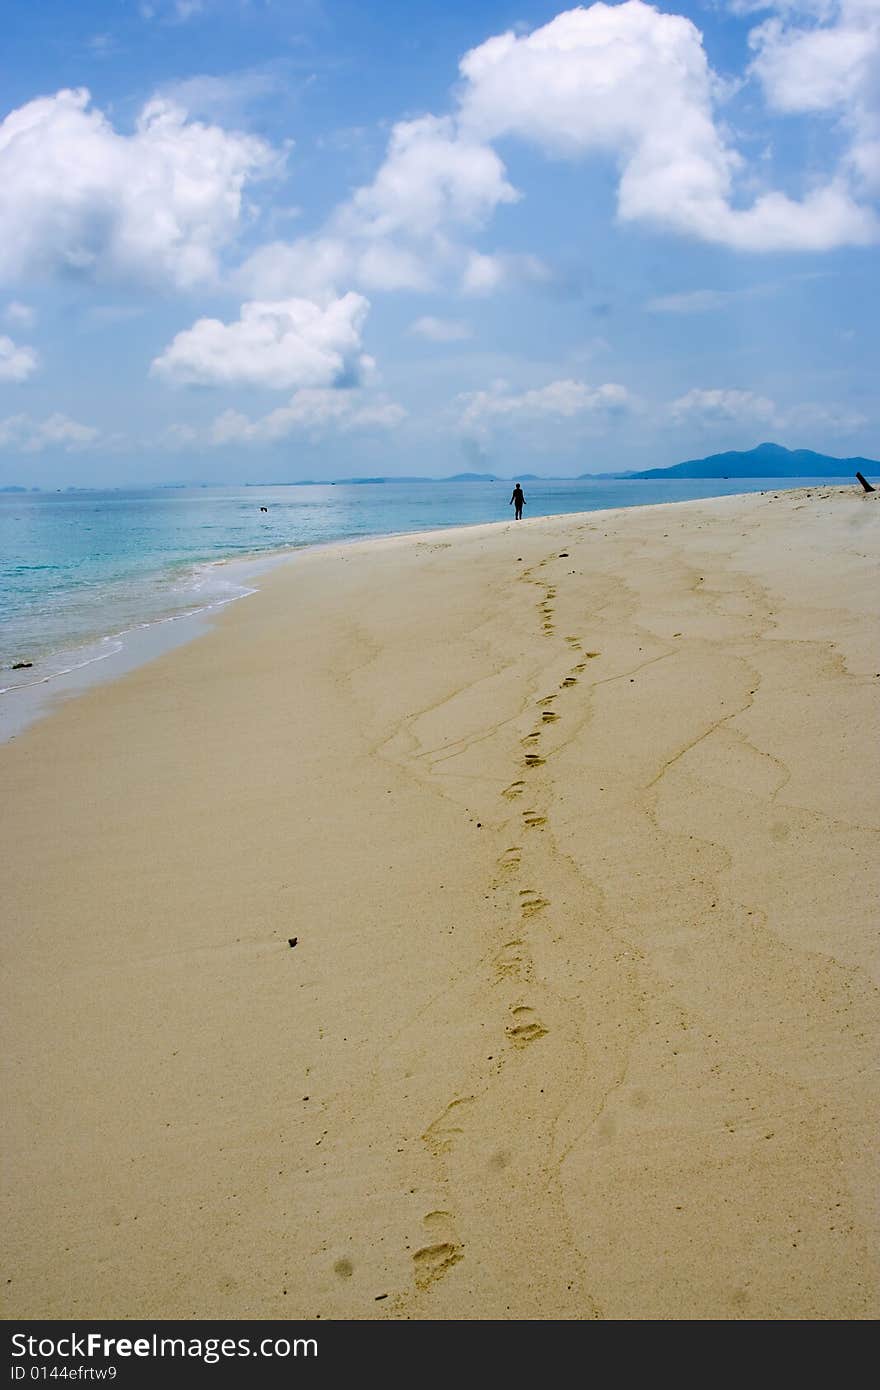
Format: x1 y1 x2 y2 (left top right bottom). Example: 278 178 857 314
0 478 841 739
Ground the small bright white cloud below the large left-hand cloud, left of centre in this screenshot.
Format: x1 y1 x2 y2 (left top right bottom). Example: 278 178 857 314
150 293 370 391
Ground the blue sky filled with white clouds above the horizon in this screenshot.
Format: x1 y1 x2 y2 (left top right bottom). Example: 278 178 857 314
0 0 880 487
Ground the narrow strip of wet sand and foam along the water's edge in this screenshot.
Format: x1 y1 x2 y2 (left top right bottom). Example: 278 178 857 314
0 480 848 746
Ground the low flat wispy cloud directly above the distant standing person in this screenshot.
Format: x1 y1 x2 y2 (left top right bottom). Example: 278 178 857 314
459 379 634 435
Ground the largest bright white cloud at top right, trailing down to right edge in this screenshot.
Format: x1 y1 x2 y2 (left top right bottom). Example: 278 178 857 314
459 0 880 250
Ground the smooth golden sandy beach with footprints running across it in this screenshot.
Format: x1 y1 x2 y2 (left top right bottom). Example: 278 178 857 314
0 485 880 1319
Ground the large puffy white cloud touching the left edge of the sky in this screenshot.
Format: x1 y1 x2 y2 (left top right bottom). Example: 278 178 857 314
0 89 277 288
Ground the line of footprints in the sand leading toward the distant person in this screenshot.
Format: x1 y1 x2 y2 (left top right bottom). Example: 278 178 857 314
413 542 599 1291
